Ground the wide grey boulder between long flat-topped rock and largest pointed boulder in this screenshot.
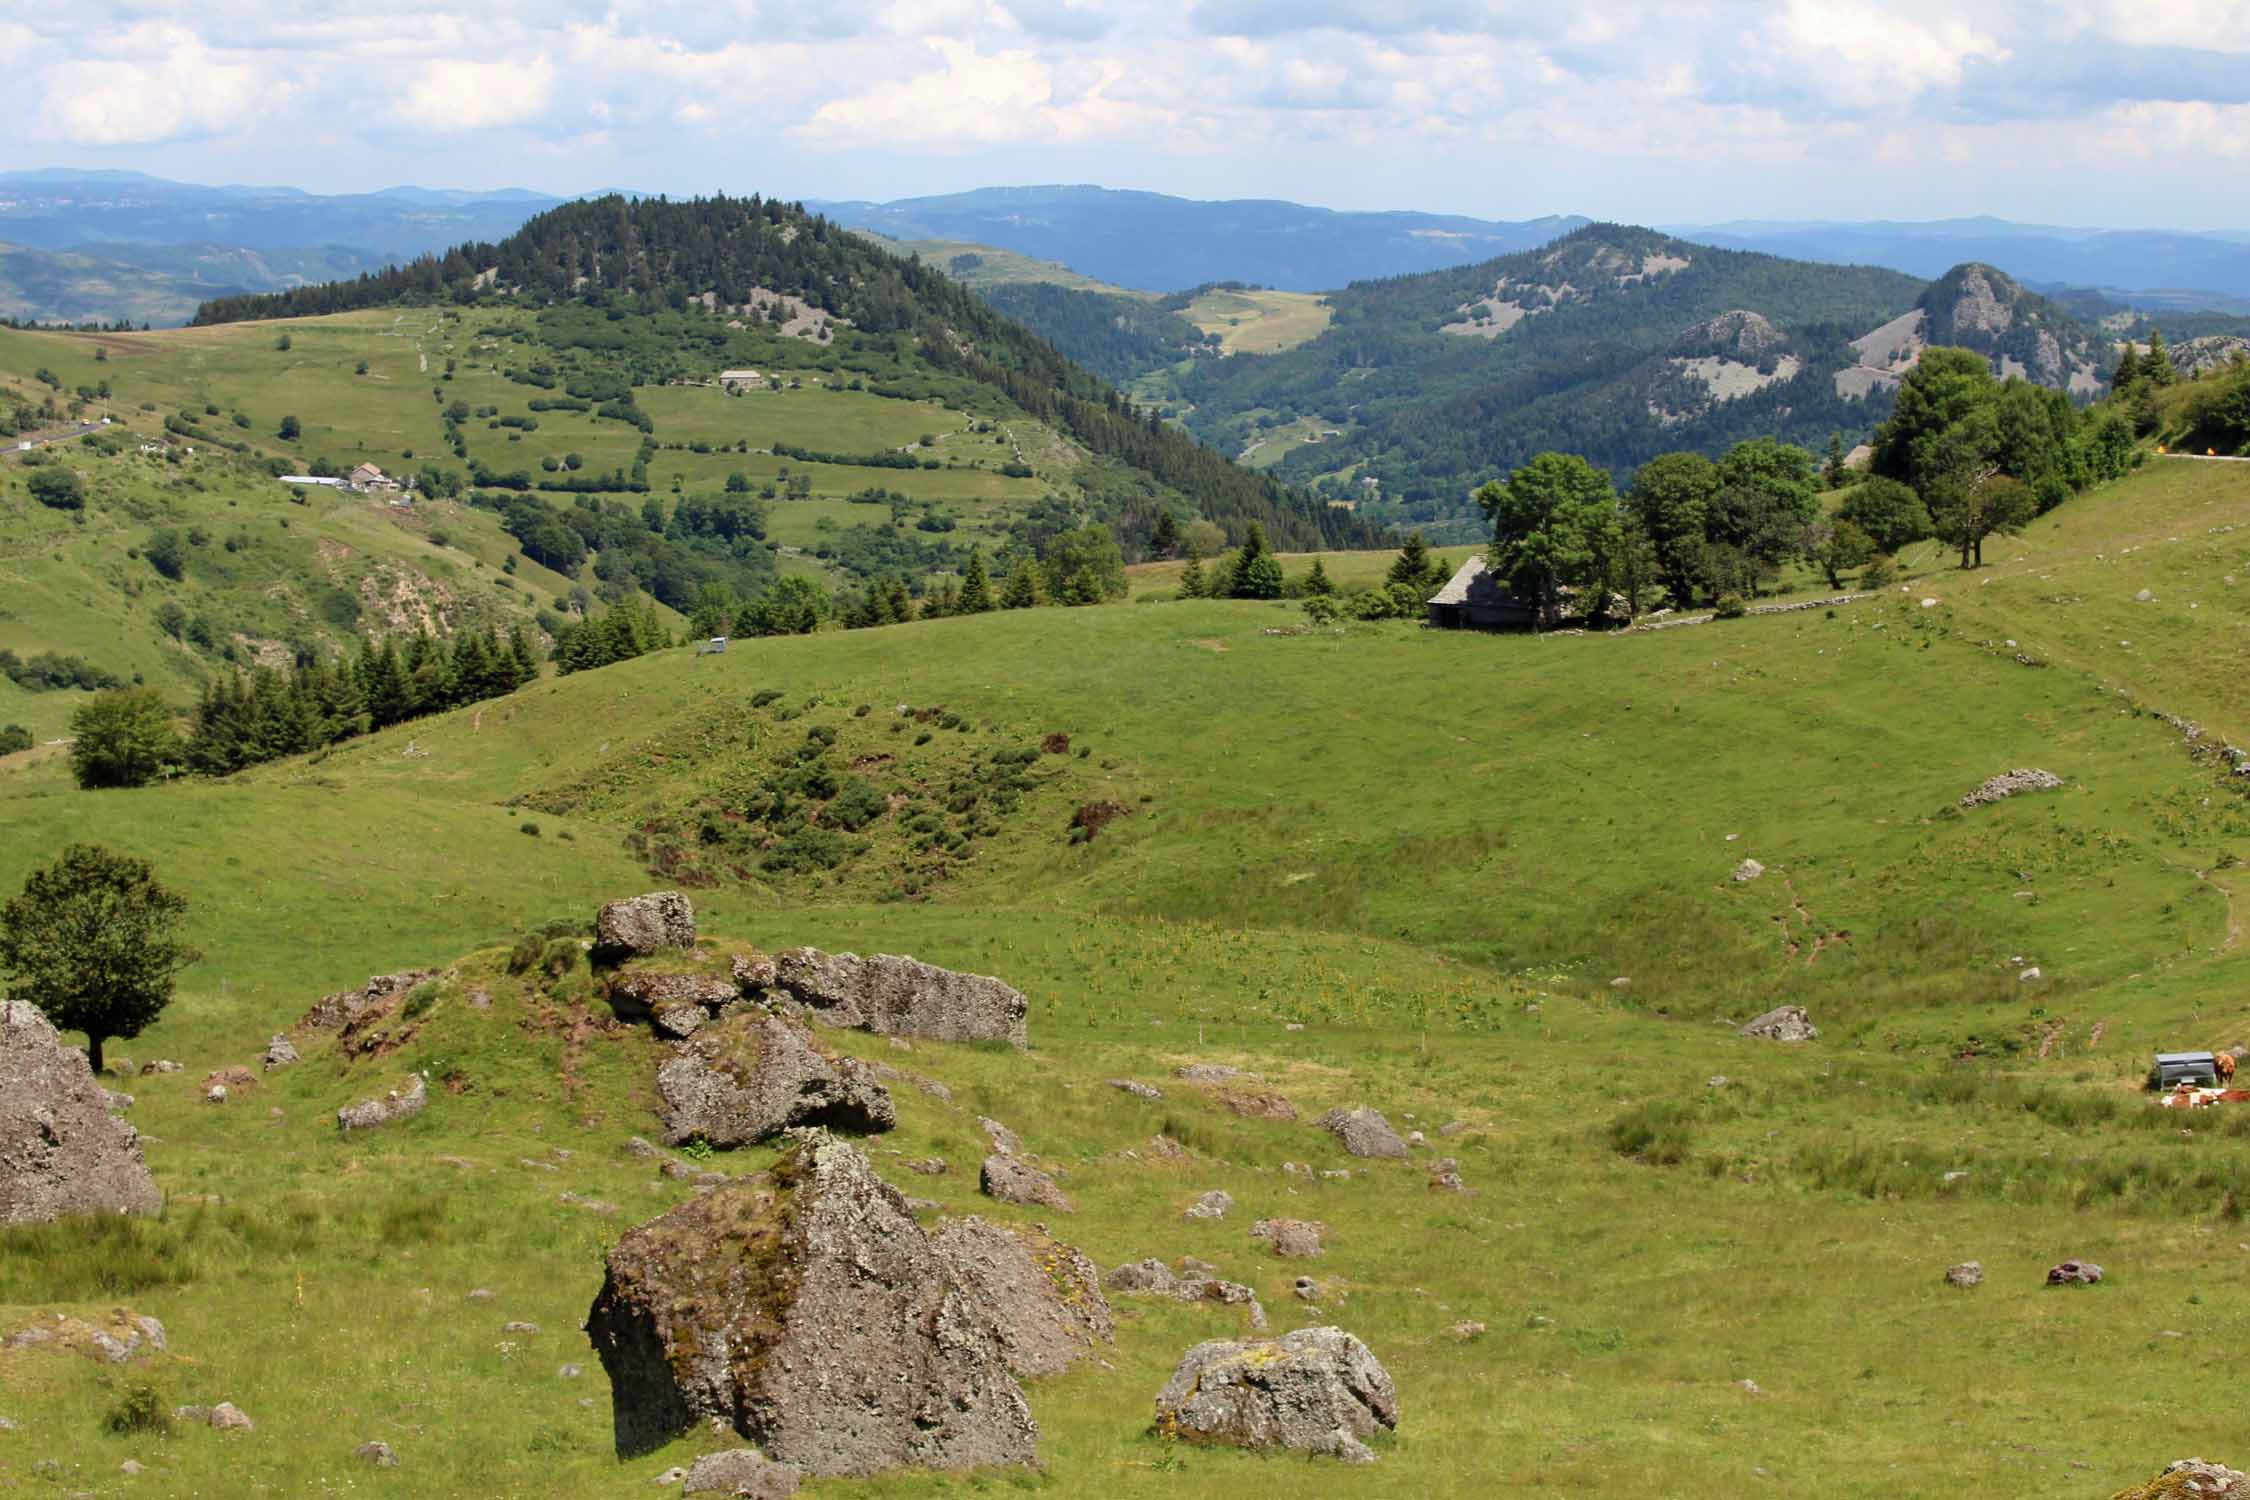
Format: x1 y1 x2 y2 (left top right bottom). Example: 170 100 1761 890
657 1010 898 1149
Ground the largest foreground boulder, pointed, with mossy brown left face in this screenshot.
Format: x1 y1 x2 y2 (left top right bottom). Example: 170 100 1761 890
587 1133 1040 1475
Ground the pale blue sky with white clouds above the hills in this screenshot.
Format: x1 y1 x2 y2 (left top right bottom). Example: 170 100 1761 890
0 0 2250 227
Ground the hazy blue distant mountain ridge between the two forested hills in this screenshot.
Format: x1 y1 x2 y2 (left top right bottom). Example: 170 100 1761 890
808 187 1586 292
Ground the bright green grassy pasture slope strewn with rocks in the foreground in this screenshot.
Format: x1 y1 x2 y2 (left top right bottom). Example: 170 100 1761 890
0 466 2250 1496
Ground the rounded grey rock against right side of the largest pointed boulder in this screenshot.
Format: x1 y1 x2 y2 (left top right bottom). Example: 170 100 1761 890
932 1217 1116 1376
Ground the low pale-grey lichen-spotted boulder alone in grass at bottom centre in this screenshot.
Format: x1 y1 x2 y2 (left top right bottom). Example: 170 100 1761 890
1157 1327 1400 1464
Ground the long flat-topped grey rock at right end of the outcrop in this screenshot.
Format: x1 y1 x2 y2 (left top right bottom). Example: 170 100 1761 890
774 949 1031 1048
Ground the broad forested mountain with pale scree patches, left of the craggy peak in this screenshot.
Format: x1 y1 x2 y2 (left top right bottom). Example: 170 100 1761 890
1175 225 1924 524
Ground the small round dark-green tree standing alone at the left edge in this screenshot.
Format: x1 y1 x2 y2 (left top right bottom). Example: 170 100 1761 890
0 843 200 1073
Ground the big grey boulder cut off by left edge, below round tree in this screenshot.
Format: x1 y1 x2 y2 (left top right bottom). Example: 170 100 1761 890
0 1001 162 1223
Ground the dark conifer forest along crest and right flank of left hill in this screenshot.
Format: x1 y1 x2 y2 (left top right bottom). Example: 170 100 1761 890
196 196 1373 546
